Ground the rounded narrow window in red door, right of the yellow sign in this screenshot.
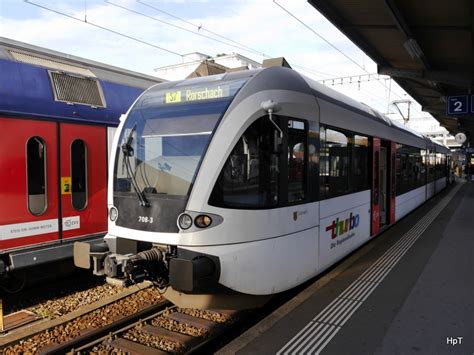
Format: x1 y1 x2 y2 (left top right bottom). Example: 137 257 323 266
71 139 87 211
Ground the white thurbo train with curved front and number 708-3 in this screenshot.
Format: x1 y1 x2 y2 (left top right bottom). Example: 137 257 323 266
76 67 450 308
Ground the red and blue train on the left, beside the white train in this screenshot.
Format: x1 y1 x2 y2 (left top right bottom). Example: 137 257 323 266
0 38 160 290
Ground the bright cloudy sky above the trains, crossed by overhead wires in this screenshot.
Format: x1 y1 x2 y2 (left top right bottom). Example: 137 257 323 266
0 0 448 131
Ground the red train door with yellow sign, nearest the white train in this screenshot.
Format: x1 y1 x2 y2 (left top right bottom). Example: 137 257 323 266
60 123 107 239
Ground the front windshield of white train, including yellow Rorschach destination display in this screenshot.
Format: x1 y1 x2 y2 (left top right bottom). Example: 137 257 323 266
114 80 244 205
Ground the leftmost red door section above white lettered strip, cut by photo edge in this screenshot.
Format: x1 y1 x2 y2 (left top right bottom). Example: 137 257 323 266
0 118 59 251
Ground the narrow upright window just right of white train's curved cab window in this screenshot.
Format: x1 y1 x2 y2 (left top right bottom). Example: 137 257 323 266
288 120 307 204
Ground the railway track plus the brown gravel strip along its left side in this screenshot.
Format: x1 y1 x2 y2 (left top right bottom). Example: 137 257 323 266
0 287 245 355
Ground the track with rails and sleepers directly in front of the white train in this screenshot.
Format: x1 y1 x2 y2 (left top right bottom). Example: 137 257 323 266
43 304 239 354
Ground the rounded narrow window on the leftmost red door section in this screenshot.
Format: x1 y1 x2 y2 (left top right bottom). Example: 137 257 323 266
26 137 48 216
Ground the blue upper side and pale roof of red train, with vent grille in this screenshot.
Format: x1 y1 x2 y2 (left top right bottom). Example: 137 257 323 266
0 37 163 125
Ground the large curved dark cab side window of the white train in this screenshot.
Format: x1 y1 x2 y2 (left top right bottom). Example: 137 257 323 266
209 116 282 209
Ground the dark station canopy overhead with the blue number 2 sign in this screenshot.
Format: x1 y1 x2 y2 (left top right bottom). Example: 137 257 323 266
308 0 474 147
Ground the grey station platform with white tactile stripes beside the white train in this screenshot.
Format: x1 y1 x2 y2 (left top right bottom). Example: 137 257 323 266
218 180 474 354
